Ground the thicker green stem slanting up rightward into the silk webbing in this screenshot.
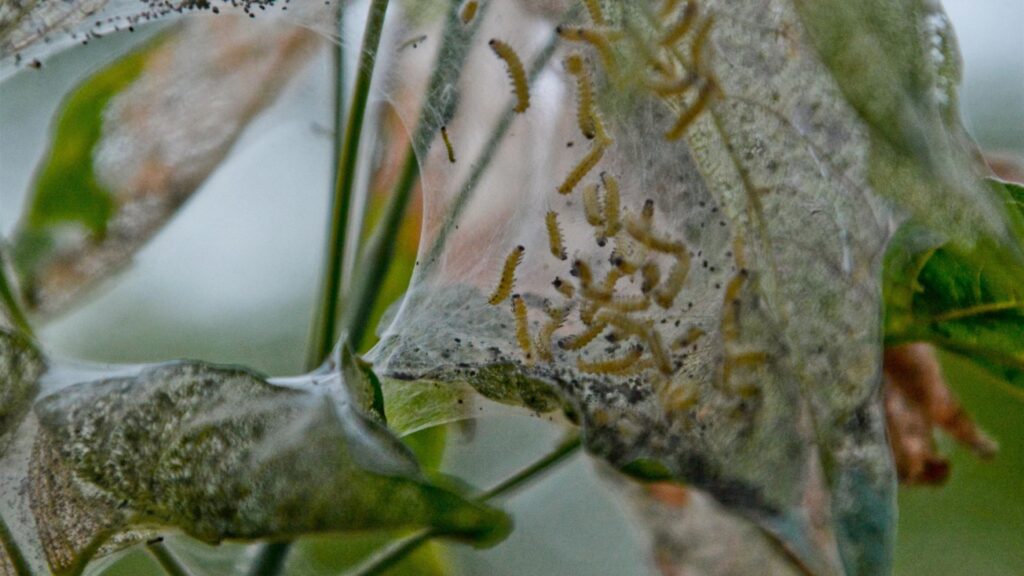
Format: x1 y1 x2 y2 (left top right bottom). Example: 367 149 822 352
342 0 489 347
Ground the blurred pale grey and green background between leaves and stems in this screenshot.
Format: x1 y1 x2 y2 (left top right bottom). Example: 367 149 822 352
0 0 1024 576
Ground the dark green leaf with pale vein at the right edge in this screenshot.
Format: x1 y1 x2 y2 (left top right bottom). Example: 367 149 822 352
885 180 1024 399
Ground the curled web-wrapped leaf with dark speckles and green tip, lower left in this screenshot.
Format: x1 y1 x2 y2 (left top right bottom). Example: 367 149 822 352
4 364 509 573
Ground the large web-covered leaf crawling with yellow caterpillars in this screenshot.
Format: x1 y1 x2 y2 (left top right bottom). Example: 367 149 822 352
358 1 1006 574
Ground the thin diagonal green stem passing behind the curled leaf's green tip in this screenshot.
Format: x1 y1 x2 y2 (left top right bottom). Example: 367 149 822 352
346 435 582 576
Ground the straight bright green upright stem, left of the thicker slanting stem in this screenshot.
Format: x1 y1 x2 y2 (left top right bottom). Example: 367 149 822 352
306 0 388 366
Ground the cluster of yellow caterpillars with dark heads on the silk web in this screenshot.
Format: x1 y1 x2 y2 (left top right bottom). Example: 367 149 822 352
479 0 737 410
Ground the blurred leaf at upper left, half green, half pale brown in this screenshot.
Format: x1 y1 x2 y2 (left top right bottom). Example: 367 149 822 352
11 15 316 315
